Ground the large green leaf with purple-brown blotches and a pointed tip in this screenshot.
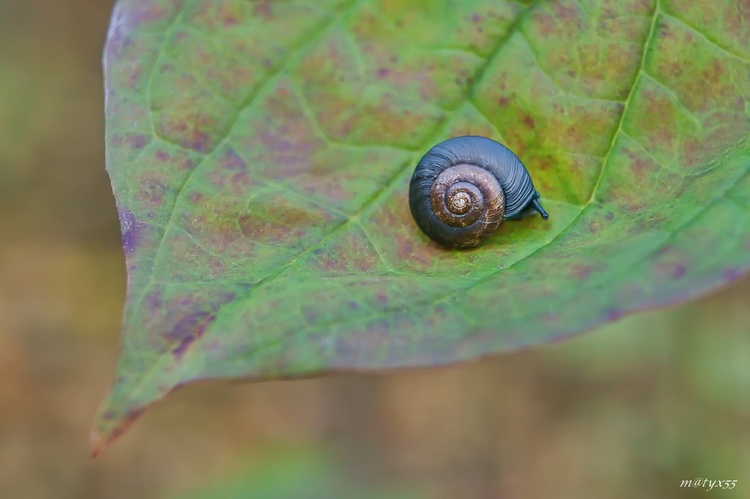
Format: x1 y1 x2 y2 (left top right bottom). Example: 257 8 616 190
94 0 750 449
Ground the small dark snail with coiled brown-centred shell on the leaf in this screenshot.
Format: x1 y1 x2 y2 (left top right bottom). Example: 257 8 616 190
409 136 549 248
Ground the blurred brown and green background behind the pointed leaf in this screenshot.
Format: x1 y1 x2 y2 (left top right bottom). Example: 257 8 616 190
0 0 750 498
